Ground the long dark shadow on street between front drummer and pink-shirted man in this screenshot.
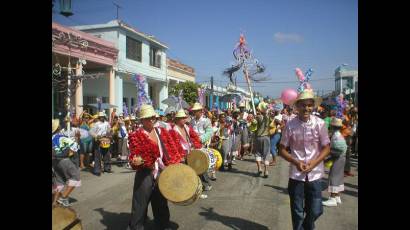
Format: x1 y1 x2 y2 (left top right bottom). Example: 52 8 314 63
199 207 269 230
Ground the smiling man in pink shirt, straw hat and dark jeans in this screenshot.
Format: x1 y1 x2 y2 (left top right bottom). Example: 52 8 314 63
279 90 330 230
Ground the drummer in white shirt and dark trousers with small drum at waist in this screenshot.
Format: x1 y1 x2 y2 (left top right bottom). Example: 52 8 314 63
90 112 112 176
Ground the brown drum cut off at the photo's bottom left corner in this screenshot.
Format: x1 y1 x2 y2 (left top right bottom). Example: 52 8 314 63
51 206 83 230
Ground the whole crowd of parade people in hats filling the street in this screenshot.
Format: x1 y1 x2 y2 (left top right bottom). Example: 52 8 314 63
52 91 358 229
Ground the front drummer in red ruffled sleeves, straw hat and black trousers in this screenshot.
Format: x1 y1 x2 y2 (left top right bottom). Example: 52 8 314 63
128 104 183 230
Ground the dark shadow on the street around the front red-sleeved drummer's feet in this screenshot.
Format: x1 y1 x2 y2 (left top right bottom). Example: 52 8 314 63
94 208 179 230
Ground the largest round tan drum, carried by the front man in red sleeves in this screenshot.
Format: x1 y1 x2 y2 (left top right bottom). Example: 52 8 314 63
158 164 202 206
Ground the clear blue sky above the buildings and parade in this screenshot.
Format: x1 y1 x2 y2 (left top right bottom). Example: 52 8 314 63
52 0 358 98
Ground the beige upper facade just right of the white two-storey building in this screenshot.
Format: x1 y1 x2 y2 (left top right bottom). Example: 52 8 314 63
167 58 195 87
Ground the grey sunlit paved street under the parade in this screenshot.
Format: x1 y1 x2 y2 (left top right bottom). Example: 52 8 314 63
71 156 358 230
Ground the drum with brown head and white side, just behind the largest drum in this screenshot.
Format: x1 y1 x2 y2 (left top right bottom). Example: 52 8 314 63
187 148 217 175
